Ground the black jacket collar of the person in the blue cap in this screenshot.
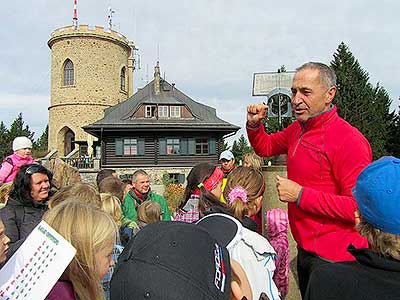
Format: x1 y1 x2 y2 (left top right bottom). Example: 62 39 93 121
347 245 400 272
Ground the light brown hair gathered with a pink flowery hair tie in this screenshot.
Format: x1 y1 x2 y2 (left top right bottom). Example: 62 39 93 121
224 166 265 220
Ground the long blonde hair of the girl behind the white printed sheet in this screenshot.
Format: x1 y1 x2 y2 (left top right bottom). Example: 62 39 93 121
43 200 118 300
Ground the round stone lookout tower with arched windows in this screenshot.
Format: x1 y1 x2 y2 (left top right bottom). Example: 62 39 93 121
47 25 135 157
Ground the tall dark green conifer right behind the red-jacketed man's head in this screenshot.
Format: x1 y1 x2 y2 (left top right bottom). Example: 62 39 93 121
331 42 391 158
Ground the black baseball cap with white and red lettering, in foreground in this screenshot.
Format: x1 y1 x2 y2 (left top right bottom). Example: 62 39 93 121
110 221 231 300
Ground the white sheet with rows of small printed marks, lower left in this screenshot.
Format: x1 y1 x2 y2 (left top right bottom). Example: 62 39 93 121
0 221 76 300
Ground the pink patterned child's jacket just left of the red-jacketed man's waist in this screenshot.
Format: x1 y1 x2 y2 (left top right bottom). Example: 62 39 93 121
265 208 290 299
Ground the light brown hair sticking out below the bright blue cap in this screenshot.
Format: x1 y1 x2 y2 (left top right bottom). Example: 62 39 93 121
357 216 400 260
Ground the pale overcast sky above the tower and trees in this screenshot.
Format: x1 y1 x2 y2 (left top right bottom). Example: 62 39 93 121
0 0 400 142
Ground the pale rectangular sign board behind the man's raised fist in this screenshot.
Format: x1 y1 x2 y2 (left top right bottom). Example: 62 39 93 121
253 72 295 96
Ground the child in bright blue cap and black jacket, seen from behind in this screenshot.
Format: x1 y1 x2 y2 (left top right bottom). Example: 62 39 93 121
305 156 400 300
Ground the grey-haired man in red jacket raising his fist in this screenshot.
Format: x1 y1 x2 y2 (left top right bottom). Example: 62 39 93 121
247 62 372 297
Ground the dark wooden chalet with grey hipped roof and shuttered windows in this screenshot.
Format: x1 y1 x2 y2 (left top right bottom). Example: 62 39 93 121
83 63 239 168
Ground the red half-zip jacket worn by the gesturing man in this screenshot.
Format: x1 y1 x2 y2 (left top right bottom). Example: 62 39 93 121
247 106 372 262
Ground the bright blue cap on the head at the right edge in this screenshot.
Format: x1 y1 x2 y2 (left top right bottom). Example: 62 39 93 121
353 156 400 234
